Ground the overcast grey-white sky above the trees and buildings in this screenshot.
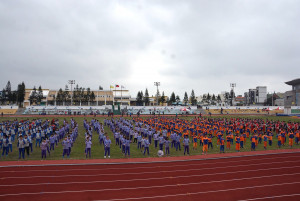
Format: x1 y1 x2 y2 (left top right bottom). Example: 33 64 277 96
0 0 300 98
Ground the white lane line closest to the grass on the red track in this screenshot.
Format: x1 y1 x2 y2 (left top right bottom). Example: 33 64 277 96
0 156 299 174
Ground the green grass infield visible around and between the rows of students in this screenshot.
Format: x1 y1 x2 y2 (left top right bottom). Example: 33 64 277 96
0 115 300 161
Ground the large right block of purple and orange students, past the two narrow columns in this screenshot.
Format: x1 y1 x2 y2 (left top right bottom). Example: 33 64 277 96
104 117 300 157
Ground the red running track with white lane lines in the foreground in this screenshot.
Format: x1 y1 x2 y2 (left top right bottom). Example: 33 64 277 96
0 153 300 201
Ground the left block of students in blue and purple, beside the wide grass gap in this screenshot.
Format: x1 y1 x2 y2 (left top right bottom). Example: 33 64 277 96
0 119 78 160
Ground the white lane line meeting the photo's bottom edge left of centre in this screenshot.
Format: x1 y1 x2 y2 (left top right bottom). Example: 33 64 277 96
94 182 300 201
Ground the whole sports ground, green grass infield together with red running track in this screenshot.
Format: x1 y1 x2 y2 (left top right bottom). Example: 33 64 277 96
0 116 300 201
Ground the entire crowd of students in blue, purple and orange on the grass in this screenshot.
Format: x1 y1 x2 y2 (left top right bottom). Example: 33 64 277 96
0 117 300 159
